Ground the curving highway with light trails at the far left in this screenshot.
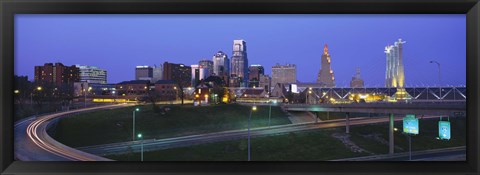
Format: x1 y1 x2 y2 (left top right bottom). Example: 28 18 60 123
14 104 128 161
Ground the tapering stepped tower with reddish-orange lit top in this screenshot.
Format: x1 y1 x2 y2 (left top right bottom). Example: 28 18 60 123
317 44 335 87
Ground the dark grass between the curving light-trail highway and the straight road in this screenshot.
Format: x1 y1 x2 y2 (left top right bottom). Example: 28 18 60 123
53 104 290 147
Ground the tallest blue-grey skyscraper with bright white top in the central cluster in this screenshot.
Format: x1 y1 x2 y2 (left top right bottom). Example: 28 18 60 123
230 40 248 87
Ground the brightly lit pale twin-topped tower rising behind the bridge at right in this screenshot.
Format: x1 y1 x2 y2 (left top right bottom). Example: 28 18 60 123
385 39 406 88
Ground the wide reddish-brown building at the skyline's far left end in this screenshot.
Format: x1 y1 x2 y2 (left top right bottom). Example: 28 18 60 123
34 63 80 86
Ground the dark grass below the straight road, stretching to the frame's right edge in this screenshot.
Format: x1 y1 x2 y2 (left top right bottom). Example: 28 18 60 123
108 115 466 161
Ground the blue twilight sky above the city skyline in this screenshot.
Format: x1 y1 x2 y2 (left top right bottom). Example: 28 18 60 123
15 14 466 87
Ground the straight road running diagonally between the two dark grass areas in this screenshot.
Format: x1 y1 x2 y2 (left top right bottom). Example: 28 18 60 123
76 116 438 156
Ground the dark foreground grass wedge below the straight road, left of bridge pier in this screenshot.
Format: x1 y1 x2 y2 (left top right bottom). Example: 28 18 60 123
108 128 367 161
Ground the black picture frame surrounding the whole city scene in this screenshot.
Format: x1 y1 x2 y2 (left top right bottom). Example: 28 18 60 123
0 0 480 174
